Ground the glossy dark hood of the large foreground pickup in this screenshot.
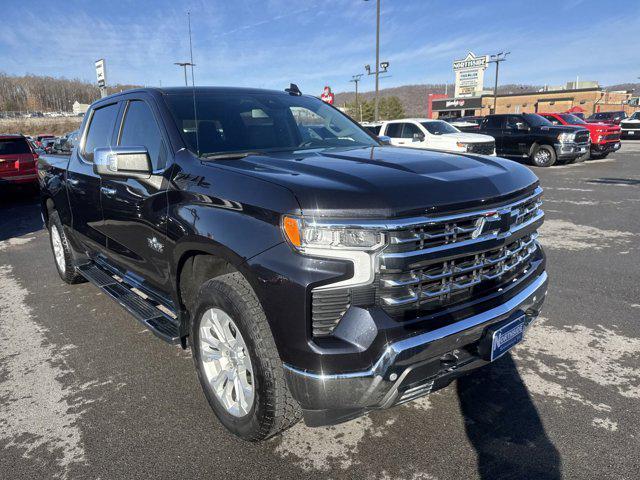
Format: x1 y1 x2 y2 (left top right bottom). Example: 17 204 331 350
211 146 538 218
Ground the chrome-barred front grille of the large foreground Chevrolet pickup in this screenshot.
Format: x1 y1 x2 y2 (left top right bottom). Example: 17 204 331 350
377 188 544 319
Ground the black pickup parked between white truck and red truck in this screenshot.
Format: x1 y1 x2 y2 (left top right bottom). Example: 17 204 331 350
476 113 591 167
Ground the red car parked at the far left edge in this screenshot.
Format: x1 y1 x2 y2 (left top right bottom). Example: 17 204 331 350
0 135 38 185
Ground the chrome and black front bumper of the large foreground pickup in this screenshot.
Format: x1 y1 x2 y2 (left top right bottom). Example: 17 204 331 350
284 271 547 426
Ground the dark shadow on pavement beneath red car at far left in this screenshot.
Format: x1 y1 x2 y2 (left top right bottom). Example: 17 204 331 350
0 184 42 241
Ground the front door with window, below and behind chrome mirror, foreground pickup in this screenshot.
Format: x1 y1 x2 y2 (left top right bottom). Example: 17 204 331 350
102 98 170 300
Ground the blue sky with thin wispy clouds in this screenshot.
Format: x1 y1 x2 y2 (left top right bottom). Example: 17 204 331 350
0 0 640 94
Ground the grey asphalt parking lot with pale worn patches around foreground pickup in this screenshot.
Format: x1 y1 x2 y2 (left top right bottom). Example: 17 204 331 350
0 142 640 480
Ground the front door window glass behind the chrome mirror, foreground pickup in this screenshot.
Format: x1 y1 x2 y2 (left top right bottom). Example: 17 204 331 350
119 100 167 170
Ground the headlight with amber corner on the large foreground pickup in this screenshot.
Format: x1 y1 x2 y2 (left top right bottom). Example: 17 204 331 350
282 215 384 251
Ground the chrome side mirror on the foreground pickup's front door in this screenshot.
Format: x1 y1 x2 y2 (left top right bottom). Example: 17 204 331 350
93 147 153 178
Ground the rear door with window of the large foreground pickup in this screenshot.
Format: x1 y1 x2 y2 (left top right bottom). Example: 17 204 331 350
63 102 119 256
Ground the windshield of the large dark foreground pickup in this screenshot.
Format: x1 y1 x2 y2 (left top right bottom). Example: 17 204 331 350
166 92 379 157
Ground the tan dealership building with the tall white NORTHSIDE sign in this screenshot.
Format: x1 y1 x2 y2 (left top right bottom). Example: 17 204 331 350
427 52 639 118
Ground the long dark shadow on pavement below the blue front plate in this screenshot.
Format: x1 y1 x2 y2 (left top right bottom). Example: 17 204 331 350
457 354 562 480
